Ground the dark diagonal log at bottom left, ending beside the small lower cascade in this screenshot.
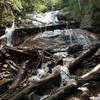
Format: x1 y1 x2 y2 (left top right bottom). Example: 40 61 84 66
9 72 60 100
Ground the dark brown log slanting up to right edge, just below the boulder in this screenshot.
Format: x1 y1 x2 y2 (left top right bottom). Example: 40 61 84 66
65 44 99 72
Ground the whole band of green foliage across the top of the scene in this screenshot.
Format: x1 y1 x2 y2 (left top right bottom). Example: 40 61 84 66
0 0 100 25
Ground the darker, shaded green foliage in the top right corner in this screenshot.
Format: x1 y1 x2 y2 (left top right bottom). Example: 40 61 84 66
64 0 100 15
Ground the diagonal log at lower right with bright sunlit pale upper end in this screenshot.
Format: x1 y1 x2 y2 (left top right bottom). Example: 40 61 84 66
46 64 100 100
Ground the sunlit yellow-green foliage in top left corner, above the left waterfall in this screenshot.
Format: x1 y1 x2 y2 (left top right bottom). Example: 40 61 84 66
0 0 22 26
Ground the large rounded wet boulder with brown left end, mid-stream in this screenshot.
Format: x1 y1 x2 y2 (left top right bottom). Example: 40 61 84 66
21 29 97 51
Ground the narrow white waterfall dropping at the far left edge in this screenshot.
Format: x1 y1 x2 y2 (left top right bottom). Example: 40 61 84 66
0 20 15 47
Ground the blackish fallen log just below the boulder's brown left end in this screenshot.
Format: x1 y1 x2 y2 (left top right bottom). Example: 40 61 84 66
4 47 40 63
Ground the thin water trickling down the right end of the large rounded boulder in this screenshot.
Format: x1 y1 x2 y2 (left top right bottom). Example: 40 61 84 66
65 29 97 49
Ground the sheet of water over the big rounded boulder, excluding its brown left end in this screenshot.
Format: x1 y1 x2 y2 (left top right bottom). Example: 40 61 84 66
38 29 97 49
